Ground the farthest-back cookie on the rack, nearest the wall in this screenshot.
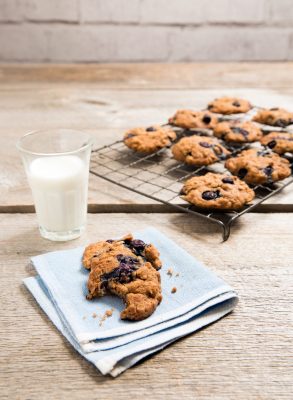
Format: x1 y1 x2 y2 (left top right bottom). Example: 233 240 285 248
208 97 252 115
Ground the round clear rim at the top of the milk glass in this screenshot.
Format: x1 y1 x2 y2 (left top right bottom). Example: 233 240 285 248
16 128 93 157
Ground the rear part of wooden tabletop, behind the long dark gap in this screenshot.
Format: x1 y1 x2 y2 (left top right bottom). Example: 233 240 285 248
0 63 293 212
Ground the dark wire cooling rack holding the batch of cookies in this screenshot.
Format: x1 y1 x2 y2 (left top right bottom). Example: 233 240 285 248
90 131 293 241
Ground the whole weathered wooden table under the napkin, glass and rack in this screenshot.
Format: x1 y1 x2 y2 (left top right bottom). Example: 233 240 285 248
0 63 293 400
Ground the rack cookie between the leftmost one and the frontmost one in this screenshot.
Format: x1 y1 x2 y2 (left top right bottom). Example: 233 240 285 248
171 135 230 166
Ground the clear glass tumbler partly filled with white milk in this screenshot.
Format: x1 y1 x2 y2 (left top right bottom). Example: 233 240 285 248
17 129 92 241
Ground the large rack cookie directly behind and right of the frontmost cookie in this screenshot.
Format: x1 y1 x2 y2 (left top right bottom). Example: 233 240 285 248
225 149 291 185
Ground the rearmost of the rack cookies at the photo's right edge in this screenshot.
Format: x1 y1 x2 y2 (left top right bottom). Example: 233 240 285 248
253 108 293 128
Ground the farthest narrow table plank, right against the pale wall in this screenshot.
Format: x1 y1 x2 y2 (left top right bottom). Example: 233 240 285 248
0 62 293 89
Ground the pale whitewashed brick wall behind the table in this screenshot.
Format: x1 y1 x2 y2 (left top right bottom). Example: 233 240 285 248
0 0 293 62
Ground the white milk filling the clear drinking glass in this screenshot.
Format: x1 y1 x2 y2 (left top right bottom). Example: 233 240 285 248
28 156 88 232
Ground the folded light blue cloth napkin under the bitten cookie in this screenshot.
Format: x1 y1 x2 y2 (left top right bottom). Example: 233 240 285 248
24 228 237 376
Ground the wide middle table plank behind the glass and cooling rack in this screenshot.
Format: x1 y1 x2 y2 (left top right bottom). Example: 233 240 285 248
0 82 293 212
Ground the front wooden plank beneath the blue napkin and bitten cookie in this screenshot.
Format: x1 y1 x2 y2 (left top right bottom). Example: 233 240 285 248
0 214 293 400
